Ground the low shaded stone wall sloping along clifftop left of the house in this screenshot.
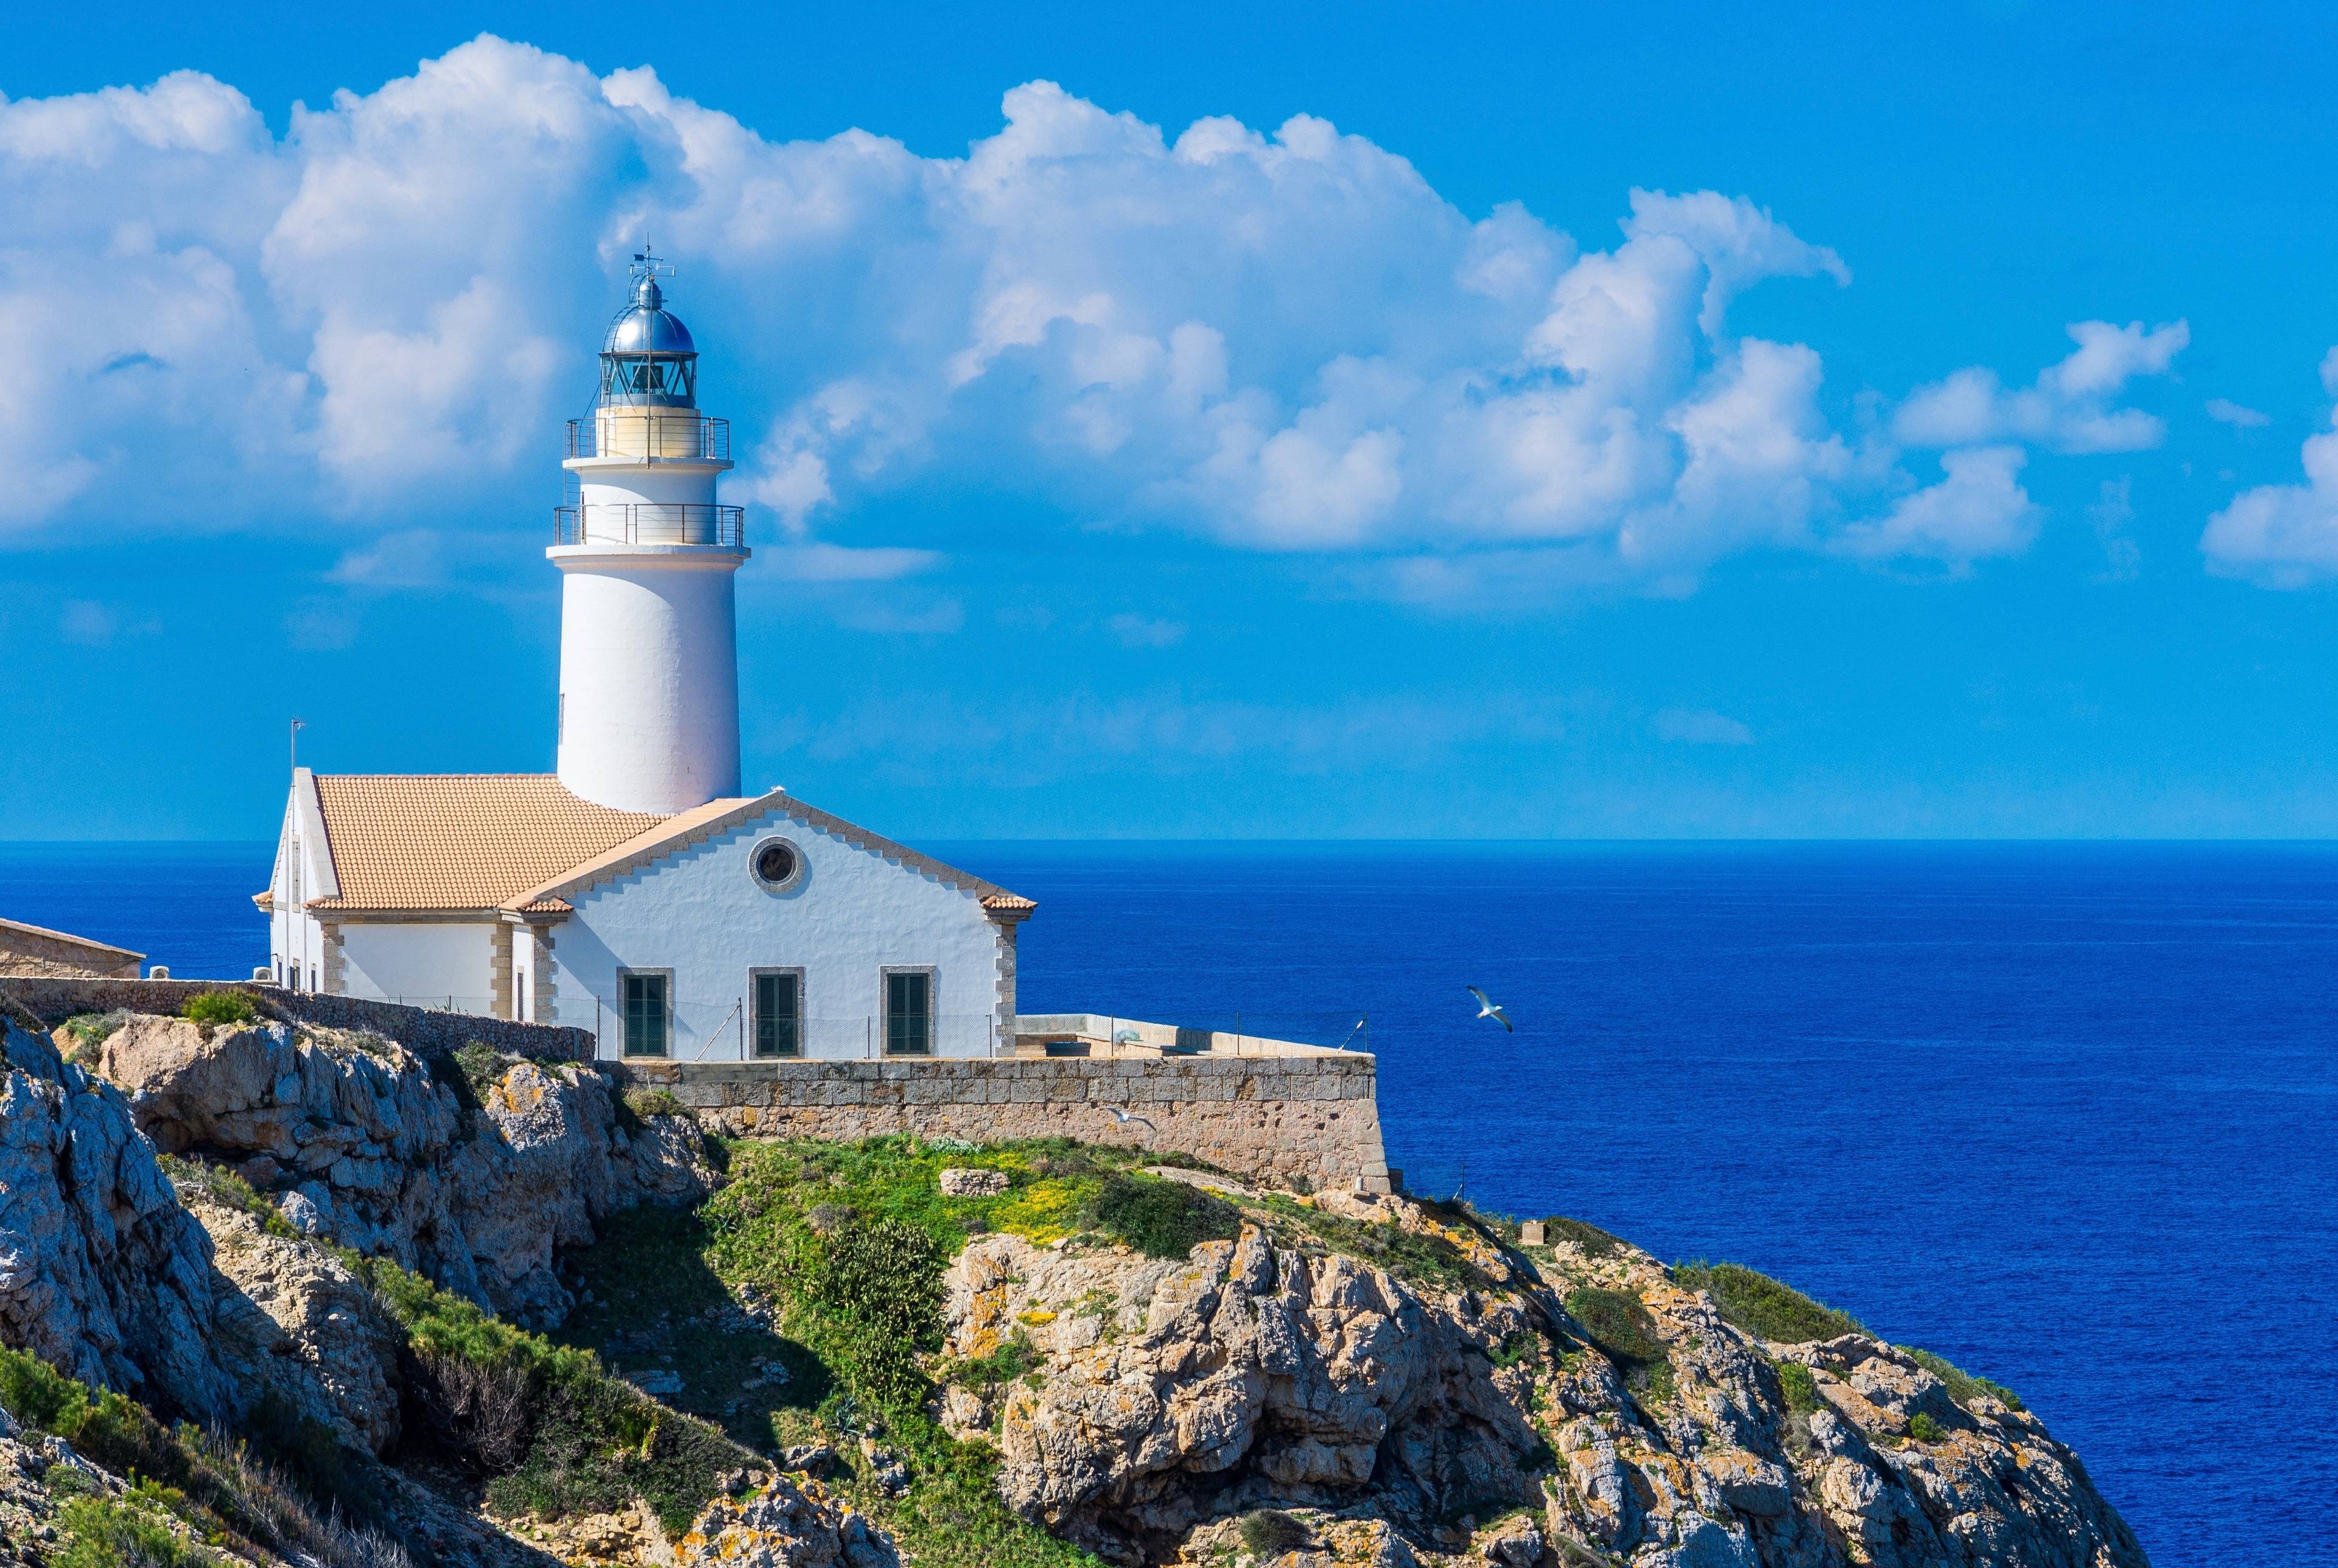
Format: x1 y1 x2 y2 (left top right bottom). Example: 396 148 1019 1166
0 977 592 1061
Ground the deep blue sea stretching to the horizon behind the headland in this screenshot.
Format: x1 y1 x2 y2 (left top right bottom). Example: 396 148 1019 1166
0 844 2338 1568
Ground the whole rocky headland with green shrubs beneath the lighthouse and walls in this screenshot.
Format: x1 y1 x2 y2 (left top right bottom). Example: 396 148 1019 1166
0 1019 2144 1568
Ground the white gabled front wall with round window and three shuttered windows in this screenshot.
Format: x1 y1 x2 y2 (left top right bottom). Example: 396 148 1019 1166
545 808 1001 1061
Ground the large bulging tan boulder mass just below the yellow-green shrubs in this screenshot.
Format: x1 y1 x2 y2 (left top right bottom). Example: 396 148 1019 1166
947 1227 1543 1561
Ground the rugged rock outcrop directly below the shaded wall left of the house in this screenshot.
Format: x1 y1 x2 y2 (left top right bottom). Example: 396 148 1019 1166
98 1017 706 1325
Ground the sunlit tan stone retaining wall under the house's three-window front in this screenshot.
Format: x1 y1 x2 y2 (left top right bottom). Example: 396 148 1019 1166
601 1052 1389 1192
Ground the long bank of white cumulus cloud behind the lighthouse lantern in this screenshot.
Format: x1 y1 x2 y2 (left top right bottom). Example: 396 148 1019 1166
0 37 2188 601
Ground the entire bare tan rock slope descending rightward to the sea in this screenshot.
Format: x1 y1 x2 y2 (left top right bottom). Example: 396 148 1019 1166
938 1194 2146 1568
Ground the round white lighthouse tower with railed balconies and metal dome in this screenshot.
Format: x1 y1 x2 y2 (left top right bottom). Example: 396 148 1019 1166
545 254 748 813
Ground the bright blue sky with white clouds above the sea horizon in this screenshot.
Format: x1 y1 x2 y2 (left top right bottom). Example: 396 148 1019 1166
0 5 2338 839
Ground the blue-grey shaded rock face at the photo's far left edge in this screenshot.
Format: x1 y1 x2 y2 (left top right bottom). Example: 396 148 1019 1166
0 1024 236 1418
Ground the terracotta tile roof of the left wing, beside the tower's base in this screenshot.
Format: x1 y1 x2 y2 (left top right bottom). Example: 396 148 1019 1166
309 774 666 911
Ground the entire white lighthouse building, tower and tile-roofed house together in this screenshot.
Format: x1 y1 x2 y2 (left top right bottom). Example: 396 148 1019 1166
255 262 1033 1061
